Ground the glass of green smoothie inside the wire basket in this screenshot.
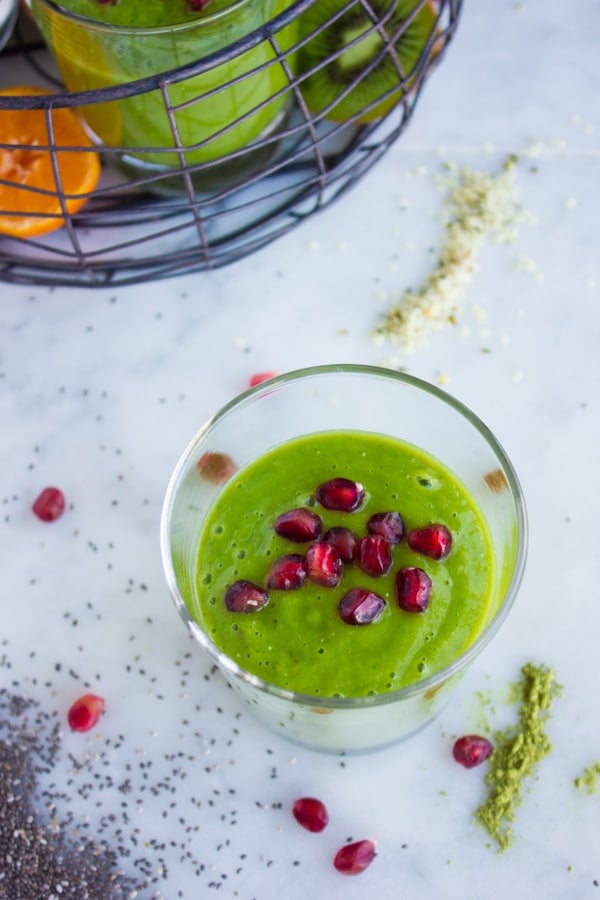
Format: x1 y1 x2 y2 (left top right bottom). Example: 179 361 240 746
28 0 296 190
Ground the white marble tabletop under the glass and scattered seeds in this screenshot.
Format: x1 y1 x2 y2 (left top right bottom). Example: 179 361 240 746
0 0 600 900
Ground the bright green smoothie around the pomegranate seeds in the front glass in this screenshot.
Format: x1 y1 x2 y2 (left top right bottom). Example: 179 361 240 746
195 431 494 697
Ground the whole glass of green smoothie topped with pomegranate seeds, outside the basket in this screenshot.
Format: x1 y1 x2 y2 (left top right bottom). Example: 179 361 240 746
161 365 527 752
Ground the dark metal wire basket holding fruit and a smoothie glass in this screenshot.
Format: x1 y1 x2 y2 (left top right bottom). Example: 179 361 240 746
0 0 462 287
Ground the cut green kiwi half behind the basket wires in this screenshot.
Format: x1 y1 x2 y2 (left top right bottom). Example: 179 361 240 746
300 0 437 124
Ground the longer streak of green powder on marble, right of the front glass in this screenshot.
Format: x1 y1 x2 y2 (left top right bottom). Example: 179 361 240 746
475 663 561 850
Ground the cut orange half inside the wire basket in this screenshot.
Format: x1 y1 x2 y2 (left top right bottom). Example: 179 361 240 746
0 86 100 238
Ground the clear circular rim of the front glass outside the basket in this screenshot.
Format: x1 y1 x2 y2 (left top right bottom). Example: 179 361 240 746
160 363 528 710
